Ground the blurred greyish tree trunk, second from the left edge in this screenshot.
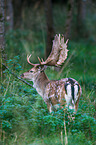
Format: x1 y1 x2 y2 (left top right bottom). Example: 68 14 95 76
6 0 13 30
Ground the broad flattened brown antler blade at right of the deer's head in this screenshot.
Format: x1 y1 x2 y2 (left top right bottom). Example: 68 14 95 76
38 34 68 66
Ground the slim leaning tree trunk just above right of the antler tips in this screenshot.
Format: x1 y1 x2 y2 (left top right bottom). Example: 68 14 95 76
65 0 74 39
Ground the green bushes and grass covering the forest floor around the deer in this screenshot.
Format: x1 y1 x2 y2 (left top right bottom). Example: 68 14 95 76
0 2 96 145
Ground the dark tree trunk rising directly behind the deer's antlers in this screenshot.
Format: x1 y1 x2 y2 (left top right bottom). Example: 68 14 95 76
44 0 54 58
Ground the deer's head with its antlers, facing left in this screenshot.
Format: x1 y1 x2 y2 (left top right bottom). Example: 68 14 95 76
21 34 68 81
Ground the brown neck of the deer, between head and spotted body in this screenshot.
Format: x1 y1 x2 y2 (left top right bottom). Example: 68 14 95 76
33 72 49 97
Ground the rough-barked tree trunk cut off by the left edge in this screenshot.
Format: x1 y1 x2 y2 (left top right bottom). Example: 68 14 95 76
0 0 5 80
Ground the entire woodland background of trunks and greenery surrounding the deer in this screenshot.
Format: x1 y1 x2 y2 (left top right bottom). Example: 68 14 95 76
0 0 96 145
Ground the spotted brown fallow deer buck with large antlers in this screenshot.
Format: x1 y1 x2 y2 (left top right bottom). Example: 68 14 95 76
21 34 81 112
